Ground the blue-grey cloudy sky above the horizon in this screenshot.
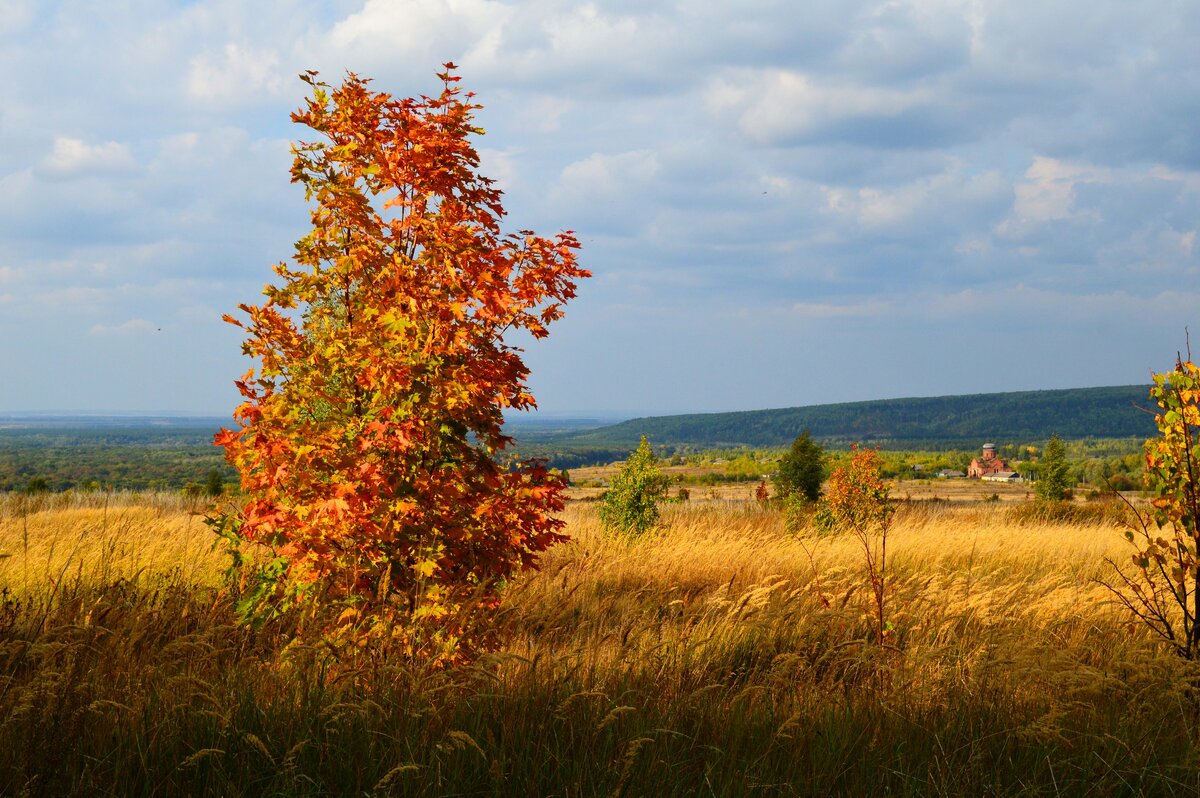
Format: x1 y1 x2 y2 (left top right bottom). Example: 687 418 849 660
0 0 1200 415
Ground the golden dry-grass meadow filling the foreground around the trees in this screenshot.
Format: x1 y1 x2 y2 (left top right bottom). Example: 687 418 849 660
0 486 1200 797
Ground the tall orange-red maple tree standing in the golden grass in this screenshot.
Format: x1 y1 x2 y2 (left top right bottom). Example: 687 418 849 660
212 64 588 660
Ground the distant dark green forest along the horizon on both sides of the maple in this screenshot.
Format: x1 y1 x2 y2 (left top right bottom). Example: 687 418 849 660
0 385 1154 491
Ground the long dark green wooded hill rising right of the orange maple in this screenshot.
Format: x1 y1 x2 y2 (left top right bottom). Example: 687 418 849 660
522 385 1154 461
